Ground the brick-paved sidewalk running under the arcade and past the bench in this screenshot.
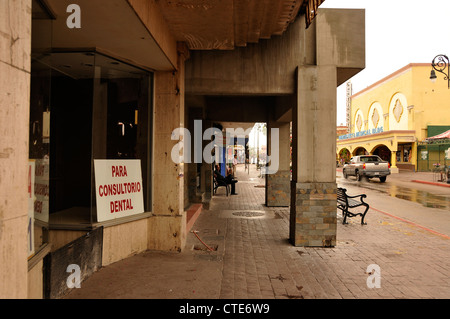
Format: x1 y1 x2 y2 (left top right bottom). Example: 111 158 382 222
200 165 450 299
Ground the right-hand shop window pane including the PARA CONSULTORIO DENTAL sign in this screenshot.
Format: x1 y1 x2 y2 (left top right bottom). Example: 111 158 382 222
92 54 151 221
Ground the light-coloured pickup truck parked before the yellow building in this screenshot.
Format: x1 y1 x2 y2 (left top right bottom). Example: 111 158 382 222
342 155 391 183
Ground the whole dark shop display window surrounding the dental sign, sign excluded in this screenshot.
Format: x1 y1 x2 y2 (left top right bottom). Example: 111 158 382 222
30 52 151 229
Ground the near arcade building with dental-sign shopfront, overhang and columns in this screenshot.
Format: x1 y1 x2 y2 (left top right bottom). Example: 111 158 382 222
0 0 365 298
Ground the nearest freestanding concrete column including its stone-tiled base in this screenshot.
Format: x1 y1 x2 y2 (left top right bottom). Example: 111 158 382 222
290 65 337 247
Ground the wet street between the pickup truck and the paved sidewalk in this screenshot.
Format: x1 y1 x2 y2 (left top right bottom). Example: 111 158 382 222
336 169 450 240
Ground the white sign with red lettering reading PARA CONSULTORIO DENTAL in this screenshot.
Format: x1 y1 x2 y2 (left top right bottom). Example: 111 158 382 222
94 160 144 222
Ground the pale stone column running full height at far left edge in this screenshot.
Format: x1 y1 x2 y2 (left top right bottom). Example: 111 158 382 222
0 0 33 299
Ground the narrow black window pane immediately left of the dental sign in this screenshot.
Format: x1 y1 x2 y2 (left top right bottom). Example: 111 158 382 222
50 53 95 226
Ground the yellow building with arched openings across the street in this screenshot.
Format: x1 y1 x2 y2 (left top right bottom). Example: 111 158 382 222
336 63 450 173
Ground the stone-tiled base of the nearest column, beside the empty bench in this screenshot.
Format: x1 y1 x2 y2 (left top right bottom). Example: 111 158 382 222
289 181 337 247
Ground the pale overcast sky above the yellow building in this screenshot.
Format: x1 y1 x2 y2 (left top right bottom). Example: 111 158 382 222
319 0 450 125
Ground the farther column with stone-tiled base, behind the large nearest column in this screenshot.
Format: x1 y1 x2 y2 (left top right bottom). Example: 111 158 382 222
266 121 291 207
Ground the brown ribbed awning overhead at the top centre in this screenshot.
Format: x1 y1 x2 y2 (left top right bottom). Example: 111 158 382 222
151 0 325 50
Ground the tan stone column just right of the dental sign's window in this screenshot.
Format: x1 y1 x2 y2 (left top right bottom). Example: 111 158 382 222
148 47 186 251
